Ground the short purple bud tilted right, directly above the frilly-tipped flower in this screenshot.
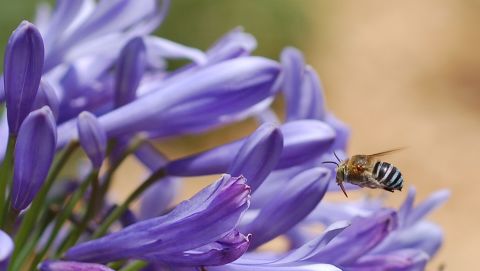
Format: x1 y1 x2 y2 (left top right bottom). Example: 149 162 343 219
227 124 283 192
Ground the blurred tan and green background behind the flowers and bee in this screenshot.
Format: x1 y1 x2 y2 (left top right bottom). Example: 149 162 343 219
0 0 480 271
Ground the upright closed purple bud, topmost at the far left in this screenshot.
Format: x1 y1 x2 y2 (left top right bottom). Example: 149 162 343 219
4 21 43 135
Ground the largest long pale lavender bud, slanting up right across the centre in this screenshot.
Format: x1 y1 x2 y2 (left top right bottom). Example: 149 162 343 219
59 57 279 146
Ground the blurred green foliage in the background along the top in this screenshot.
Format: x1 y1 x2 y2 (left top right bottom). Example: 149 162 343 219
0 0 324 72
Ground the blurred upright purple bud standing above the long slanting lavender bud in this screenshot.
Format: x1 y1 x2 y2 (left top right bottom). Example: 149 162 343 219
114 37 146 107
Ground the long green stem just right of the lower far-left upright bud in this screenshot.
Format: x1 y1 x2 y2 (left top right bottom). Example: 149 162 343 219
10 142 79 266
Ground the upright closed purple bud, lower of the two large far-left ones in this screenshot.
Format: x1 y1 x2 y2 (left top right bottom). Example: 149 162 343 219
12 106 57 211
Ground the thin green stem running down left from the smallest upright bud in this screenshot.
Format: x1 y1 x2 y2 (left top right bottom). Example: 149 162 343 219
27 170 98 268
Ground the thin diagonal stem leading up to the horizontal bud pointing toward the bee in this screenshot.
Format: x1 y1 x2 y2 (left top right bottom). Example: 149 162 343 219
92 168 166 239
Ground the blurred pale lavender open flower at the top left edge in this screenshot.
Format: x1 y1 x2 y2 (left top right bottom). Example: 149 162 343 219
42 0 169 71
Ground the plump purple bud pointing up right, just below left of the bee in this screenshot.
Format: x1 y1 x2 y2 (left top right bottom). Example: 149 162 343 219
241 168 329 249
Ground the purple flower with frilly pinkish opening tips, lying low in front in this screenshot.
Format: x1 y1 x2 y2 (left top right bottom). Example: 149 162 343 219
65 175 250 265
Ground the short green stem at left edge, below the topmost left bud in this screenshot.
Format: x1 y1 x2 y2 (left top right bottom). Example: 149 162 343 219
0 135 16 228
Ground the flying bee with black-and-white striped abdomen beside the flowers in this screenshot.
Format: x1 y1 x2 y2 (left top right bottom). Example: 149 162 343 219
323 149 403 198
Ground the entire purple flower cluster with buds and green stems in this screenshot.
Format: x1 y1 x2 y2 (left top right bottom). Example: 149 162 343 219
0 0 448 271
